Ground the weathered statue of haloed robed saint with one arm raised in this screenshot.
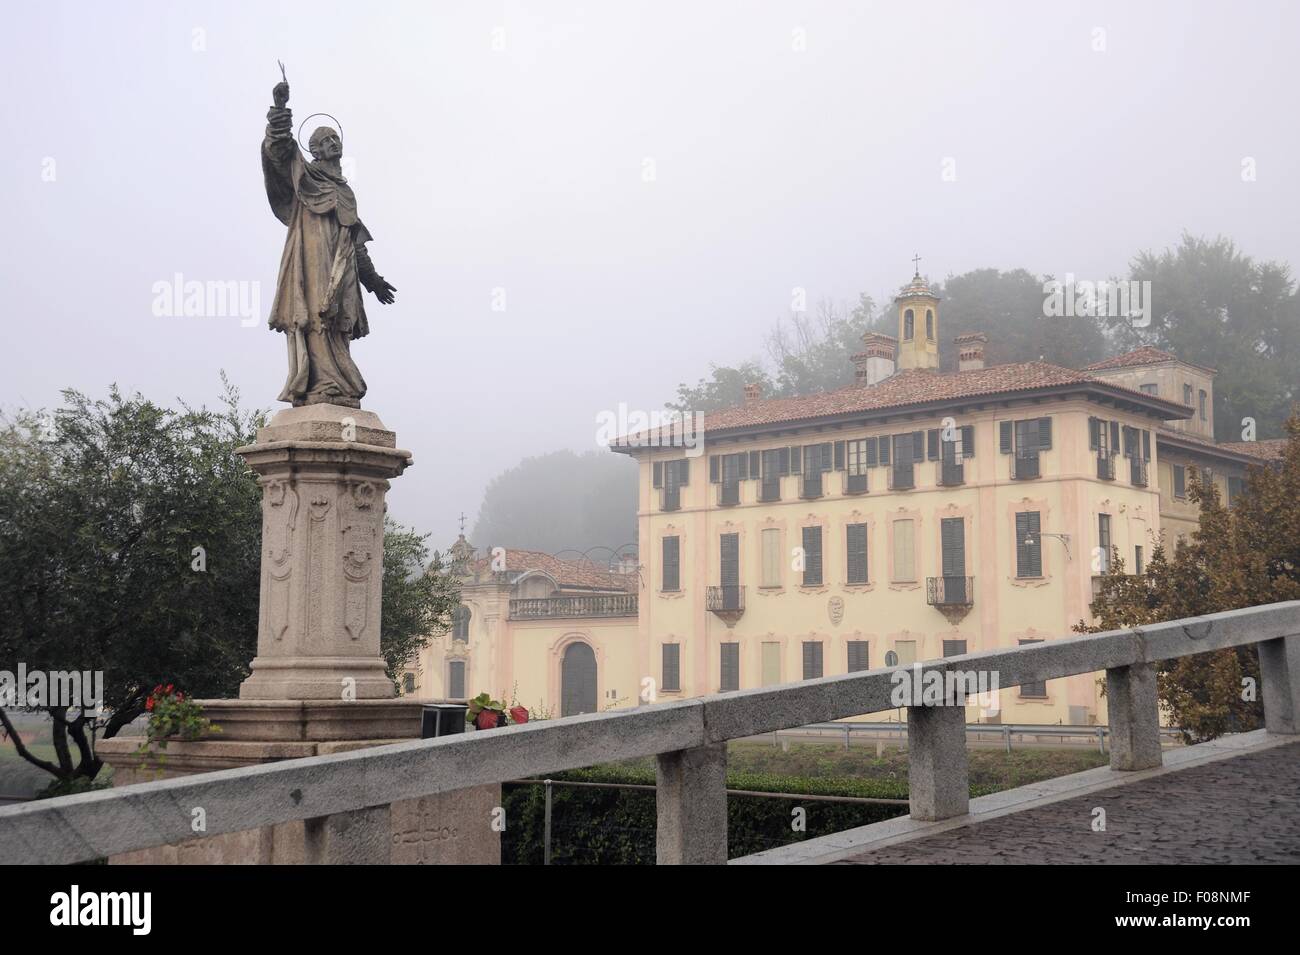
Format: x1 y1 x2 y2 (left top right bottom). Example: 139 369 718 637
261 82 397 408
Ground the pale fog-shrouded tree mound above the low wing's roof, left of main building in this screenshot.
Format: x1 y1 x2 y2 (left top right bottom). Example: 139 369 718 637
471 451 637 554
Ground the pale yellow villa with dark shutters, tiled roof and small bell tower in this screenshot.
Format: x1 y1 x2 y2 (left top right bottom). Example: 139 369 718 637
420 268 1277 724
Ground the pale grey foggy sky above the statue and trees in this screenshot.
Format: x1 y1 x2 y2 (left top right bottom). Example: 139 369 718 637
0 0 1300 546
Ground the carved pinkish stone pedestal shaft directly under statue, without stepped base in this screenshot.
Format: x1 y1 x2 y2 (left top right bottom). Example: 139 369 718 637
235 404 412 700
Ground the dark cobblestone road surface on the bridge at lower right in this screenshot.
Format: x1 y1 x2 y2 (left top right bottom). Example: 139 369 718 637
845 743 1300 865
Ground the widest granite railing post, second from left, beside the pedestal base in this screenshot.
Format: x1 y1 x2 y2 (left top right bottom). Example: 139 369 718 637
655 743 727 865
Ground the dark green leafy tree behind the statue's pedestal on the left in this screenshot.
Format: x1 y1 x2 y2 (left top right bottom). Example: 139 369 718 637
0 385 455 787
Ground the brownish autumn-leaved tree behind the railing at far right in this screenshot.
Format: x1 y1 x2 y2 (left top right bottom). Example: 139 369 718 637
1075 414 1300 742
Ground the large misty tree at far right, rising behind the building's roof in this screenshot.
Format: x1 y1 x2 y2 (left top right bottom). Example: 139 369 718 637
1114 234 1300 440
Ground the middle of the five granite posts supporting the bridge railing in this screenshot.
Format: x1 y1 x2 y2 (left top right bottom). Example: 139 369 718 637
907 704 970 821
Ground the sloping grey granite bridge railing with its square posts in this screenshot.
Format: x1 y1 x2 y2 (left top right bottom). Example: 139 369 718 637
0 600 1300 864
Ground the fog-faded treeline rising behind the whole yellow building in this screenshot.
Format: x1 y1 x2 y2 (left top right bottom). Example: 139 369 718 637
472 234 1300 552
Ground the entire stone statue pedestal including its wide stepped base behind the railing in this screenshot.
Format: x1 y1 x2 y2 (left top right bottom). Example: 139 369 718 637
96 404 501 864
